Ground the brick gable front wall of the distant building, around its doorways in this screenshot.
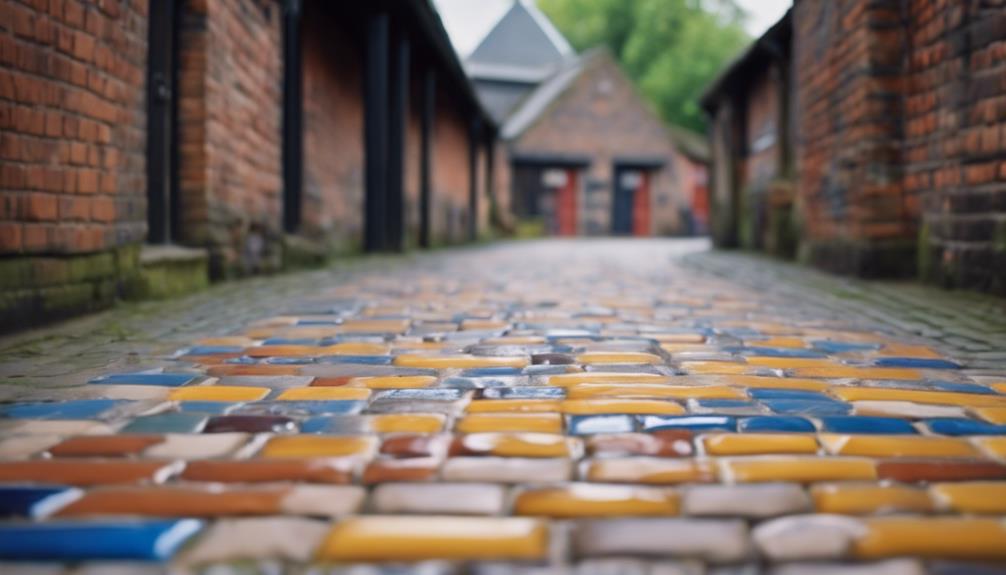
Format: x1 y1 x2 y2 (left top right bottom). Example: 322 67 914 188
513 52 681 233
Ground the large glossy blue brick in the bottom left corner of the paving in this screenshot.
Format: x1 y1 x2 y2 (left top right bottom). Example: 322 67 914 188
0 519 202 562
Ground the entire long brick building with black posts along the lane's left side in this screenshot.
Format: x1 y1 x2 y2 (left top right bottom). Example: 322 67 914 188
0 0 498 329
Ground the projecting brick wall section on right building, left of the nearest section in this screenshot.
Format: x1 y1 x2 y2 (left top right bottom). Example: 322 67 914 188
794 0 917 274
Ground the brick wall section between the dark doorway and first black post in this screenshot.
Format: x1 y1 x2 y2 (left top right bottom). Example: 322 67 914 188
179 0 283 277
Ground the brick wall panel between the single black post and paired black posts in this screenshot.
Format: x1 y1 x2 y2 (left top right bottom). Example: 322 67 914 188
302 2 364 249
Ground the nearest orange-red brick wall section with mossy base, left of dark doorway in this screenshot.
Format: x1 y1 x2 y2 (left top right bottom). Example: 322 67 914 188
0 0 147 329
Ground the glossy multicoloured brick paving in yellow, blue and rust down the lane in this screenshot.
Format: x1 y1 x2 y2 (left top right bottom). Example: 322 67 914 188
0 243 1006 575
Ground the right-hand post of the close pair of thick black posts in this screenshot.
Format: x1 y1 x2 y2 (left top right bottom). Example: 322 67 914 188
385 26 409 251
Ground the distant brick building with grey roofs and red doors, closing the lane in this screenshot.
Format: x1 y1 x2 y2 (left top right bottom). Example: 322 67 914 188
465 0 705 235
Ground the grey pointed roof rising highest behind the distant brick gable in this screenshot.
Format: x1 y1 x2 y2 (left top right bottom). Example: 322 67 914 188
466 0 575 77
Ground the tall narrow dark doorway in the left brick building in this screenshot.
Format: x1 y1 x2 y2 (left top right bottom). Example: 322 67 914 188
147 0 181 243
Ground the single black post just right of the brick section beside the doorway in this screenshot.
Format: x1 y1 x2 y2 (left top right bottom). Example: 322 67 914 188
283 0 304 233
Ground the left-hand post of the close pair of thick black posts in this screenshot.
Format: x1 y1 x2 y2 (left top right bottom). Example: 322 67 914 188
363 10 388 251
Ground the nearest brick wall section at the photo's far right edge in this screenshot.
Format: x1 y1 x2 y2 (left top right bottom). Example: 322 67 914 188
904 0 1006 293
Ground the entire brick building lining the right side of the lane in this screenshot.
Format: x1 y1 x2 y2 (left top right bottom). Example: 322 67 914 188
703 0 1006 294
